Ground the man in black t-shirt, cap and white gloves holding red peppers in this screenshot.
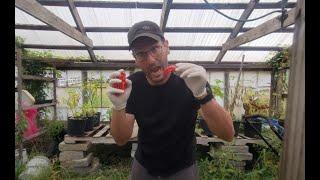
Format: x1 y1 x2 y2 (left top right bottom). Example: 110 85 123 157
108 21 234 180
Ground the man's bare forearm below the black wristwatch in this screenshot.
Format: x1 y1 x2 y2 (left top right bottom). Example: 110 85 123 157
200 99 234 142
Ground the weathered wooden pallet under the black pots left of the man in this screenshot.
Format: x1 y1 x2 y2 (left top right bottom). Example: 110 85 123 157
64 124 137 144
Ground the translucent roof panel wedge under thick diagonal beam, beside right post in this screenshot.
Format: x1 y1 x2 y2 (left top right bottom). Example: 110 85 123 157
241 33 293 47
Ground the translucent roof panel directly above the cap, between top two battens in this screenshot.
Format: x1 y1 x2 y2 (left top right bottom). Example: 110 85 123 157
77 7 161 27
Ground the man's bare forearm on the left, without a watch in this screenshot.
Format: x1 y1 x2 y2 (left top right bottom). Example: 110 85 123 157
110 109 135 146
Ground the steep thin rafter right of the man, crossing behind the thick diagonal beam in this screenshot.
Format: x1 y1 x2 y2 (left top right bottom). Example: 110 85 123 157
215 0 259 63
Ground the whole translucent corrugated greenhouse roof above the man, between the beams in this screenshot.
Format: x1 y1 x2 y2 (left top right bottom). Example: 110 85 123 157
15 0 296 62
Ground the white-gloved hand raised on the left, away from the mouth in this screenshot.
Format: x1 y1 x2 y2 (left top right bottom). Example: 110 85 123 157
107 69 132 110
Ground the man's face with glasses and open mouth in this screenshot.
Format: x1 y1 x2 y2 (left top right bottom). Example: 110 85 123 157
132 37 169 85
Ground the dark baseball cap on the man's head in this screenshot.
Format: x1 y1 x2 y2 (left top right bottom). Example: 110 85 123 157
128 21 164 50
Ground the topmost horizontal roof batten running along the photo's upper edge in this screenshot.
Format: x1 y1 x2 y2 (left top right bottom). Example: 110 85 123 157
38 0 296 10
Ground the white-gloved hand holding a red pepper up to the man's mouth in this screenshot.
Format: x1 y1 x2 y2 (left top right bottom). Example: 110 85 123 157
176 63 207 98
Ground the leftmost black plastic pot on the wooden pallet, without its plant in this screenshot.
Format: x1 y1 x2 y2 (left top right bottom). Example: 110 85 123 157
67 117 86 136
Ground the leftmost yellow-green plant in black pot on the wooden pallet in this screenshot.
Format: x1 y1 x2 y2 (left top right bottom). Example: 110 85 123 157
66 89 86 136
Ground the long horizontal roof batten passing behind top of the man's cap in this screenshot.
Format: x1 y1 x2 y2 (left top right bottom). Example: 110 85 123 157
15 24 294 33
